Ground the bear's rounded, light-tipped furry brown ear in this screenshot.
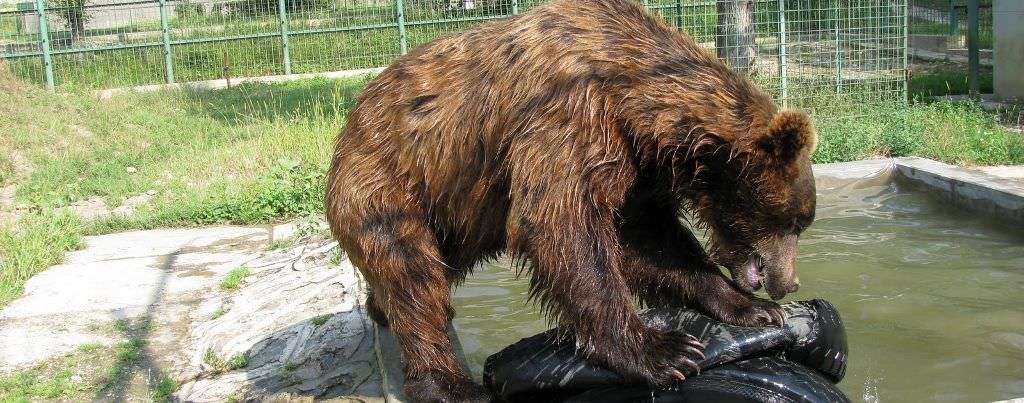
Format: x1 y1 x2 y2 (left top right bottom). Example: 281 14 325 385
758 109 818 163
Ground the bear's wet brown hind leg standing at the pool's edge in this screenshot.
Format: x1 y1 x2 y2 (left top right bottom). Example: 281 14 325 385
356 214 489 402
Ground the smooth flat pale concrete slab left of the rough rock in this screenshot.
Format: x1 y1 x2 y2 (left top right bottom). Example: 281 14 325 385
0 227 267 370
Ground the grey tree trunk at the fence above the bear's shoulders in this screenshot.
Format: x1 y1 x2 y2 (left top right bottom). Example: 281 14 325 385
715 0 756 73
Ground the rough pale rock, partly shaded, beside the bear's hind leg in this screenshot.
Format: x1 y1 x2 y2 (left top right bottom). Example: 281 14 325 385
176 241 382 402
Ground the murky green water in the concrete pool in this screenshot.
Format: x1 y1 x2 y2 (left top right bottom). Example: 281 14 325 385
455 172 1024 402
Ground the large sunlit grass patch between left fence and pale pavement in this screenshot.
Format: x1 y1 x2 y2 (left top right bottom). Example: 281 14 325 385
0 63 368 307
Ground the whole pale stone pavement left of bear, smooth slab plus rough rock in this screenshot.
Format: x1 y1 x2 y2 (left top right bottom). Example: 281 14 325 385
0 226 383 402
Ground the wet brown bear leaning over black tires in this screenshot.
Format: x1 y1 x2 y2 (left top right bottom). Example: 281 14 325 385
326 0 816 401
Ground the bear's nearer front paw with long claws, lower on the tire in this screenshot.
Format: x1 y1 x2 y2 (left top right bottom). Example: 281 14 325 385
644 331 705 388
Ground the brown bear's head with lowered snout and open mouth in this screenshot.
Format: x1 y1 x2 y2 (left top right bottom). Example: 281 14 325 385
698 109 817 300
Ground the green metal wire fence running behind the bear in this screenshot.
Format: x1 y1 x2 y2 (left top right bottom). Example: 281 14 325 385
0 0 908 118
